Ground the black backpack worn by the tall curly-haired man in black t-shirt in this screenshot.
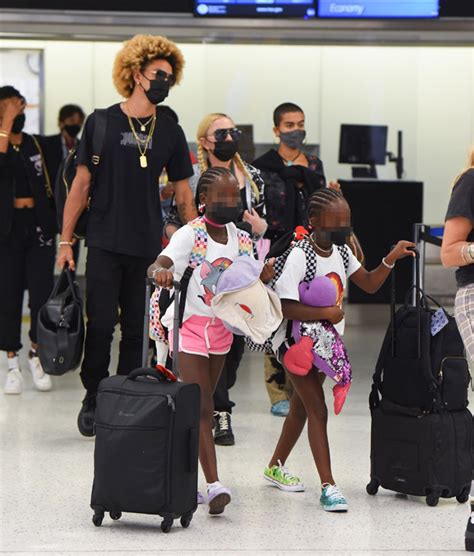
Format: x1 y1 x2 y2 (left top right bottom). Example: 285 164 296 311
54 108 107 239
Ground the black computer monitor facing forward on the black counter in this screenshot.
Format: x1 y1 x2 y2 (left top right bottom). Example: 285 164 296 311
339 124 388 166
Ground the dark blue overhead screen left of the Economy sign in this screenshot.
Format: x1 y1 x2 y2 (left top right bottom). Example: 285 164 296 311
194 0 316 19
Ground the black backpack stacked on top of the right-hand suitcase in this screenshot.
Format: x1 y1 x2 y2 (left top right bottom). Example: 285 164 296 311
370 254 471 412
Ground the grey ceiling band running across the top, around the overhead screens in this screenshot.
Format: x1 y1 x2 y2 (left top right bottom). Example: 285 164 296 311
0 0 474 46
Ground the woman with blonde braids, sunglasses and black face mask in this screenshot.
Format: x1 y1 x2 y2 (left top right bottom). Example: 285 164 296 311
165 113 267 446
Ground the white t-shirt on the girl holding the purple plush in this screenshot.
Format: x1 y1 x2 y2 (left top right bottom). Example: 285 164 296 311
275 246 361 334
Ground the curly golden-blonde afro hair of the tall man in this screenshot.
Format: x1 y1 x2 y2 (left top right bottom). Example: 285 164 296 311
112 35 184 98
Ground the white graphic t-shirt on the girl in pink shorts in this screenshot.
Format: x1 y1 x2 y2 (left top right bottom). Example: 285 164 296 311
161 220 248 330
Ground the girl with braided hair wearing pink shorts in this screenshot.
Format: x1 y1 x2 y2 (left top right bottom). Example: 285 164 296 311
148 167 271 515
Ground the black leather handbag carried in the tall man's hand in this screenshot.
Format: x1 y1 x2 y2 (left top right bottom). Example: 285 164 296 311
38 267 84 375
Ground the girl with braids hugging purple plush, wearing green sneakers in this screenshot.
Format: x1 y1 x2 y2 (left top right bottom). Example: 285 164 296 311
264 189 415 512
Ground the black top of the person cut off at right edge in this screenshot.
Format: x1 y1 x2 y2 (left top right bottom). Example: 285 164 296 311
446 169 474 288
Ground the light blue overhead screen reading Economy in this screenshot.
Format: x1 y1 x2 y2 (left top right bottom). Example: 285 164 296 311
318 0 440 19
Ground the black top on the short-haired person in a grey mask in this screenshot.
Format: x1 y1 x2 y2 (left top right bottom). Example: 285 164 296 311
253 149 326 241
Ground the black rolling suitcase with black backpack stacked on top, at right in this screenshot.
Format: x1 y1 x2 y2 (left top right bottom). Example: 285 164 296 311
367 253 473 506
